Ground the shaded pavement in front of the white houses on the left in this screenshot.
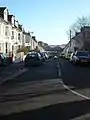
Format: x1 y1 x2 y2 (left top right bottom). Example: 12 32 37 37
0 62 25 85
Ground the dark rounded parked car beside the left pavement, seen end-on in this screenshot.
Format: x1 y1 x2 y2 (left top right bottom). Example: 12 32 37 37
24 52 43 67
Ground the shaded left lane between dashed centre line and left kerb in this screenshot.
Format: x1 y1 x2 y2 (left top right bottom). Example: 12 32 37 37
0 59 58 85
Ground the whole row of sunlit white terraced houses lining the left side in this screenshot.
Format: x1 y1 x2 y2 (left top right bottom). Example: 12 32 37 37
0 7 43 59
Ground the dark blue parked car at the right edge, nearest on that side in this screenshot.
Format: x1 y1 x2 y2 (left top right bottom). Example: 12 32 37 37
72 51 90 64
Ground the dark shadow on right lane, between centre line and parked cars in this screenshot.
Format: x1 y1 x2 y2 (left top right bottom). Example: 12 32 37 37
60 57 90 88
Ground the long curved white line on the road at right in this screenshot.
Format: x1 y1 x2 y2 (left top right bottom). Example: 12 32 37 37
60 80 90 100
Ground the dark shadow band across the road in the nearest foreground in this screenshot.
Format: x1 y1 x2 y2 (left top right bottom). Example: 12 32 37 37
0 100 90 120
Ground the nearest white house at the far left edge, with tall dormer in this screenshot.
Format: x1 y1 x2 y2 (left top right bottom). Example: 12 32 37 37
0 8 12 53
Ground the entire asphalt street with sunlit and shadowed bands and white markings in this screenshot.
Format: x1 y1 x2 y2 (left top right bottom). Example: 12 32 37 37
0 58 90 120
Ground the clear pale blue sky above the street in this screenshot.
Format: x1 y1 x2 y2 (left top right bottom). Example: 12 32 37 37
0 0 90 45
